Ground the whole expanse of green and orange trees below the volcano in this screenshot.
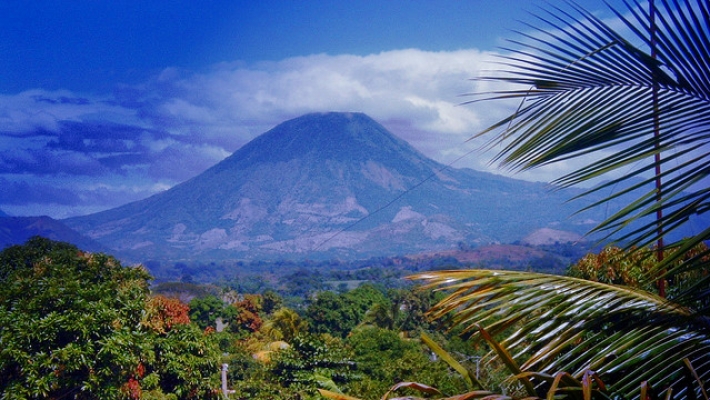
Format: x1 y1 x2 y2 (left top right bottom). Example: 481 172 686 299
0 237 708 399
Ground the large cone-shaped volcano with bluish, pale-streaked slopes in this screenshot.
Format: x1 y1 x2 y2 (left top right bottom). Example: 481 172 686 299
64 113 688 261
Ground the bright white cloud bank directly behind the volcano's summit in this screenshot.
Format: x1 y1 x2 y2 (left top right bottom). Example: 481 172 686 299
160 49 503 166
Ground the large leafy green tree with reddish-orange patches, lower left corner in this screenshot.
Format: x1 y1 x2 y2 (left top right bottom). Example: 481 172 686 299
0 238 217 399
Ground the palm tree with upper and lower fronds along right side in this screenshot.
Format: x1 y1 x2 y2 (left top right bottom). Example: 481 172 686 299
414 0 710 399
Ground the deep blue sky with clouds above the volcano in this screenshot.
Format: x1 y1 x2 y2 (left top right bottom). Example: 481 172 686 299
0 0 621 218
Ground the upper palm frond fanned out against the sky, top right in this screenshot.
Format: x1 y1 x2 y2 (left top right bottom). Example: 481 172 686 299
473 0 710 302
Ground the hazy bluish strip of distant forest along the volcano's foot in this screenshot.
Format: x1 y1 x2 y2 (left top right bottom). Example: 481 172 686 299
142 241 600 288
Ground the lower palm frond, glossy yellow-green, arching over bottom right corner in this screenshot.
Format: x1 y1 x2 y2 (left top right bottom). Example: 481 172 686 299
412 270 710 398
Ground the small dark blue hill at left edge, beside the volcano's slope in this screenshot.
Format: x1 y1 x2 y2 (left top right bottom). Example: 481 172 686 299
0 214 108 252
